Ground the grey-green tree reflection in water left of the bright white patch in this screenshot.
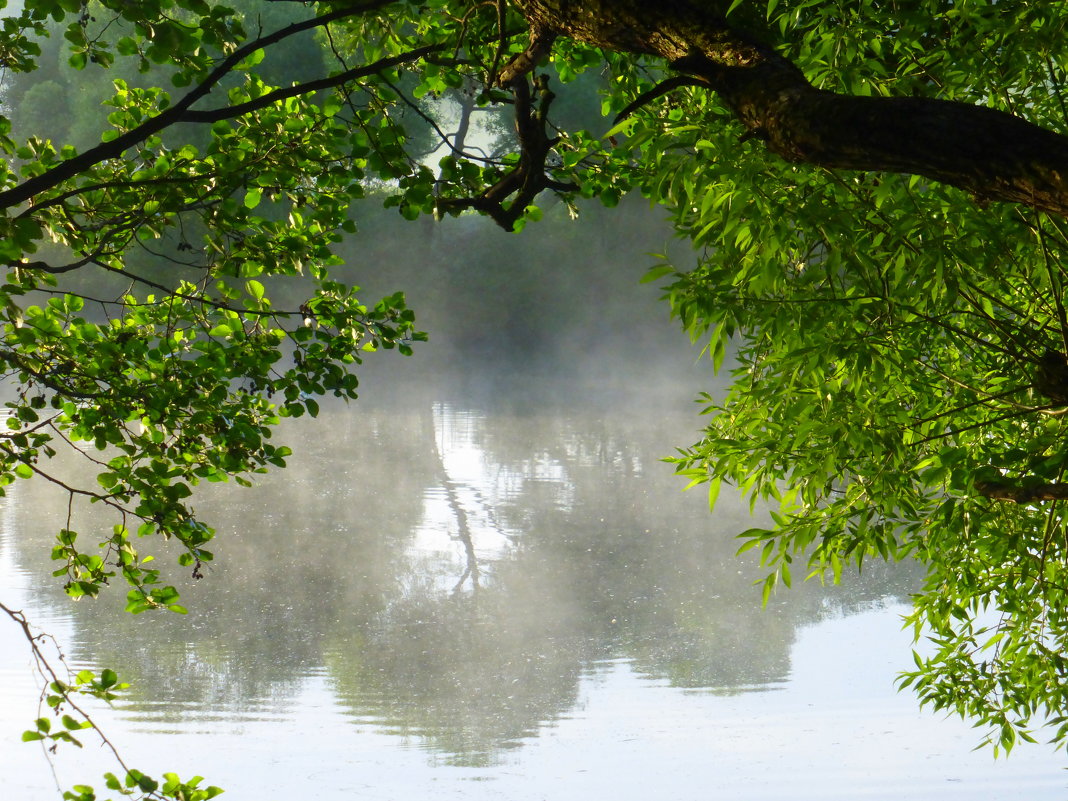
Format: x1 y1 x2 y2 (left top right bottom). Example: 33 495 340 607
6 407 434 717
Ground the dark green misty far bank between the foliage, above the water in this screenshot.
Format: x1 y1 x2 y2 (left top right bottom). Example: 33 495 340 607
324 198 722 407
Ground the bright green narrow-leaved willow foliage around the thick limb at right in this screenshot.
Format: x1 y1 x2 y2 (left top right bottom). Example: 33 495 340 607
649 2 1068 751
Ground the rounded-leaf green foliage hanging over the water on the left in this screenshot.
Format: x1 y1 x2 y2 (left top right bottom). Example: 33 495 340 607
0 3 423 612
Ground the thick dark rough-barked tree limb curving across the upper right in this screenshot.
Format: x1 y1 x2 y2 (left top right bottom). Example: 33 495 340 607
518 0 1068 217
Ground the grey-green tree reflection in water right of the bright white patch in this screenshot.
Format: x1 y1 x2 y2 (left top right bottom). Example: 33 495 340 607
469 401 918 690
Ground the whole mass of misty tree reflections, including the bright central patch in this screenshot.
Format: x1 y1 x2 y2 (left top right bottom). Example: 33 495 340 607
4 404 916 766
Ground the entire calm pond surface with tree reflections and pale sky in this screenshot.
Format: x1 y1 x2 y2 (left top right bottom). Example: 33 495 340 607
0 402 1068 801
